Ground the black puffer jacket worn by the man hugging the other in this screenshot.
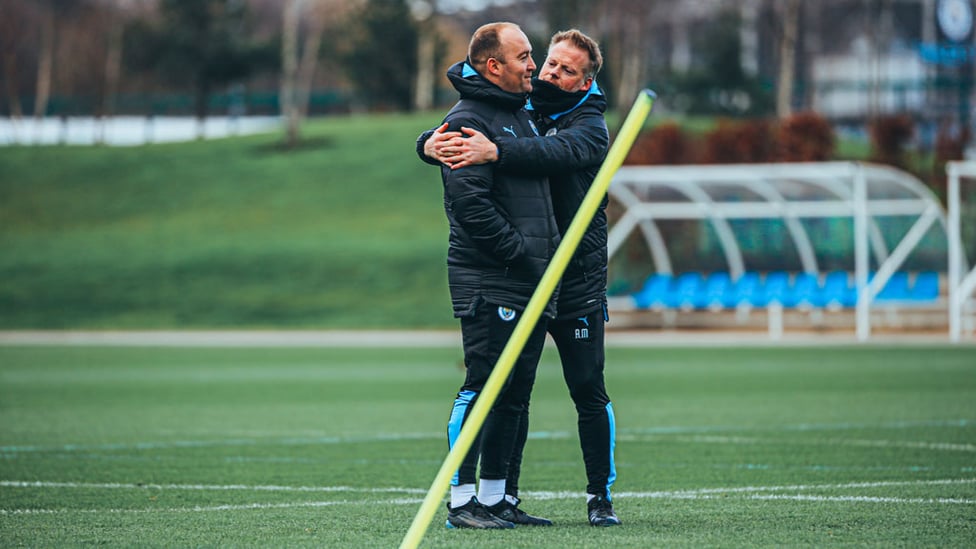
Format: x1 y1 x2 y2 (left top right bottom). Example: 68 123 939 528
492 80 610 317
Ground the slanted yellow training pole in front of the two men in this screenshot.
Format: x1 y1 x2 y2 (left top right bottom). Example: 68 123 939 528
400 90 657 549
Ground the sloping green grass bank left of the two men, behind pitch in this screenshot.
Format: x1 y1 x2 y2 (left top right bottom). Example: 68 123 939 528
0 113 454 329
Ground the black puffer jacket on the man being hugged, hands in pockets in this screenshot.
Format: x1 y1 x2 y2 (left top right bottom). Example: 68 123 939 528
432 62 560 317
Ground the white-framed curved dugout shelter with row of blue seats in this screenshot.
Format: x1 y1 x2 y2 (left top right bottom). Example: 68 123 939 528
608 162 976 341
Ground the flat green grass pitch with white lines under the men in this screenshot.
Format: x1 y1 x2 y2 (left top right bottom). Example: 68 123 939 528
0 345 976 548
